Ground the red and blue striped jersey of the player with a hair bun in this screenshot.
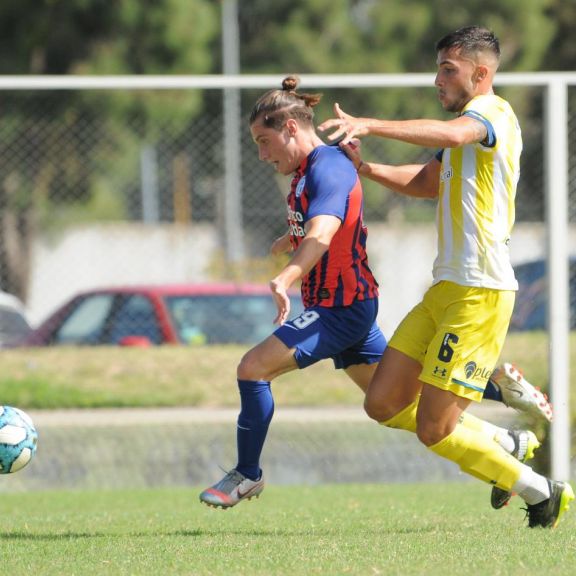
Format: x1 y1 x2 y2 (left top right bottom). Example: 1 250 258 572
288 146 378 308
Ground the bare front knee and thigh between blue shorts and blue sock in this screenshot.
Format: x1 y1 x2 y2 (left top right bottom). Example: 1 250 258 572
237 334 298 380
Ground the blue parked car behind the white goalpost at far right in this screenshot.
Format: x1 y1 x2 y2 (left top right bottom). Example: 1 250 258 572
510 257 576 330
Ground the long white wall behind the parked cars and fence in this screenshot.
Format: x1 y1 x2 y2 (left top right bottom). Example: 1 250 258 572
26 223 576 337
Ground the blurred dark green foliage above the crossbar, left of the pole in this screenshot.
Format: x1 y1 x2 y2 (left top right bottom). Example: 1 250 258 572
0 0 219 74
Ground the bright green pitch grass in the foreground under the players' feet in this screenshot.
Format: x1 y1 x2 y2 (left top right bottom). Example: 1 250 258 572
0 483 576 576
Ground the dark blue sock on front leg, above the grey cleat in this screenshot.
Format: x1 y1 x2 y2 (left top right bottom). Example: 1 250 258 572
236 380 274 480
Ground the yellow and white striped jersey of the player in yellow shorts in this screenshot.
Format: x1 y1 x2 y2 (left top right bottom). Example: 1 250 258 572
433 95 522 290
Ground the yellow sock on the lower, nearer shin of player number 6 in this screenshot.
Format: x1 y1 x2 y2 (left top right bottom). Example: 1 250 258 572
428 424 522 491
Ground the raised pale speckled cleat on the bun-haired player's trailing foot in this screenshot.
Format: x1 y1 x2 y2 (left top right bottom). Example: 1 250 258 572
490 362 552 422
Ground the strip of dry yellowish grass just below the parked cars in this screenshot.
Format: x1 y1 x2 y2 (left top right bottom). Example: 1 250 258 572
0 333 576 409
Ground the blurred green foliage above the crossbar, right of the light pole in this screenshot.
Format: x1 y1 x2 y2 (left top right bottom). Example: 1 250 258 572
239 0 566 74
